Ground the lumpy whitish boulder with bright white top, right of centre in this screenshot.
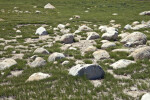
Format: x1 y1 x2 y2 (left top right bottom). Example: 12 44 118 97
102 27 118 40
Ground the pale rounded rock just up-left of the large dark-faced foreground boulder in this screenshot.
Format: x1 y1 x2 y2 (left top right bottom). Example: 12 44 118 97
48 52 65 62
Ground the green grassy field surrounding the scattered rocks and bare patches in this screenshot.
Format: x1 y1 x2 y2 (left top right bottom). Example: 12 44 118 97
0 0 150 100
